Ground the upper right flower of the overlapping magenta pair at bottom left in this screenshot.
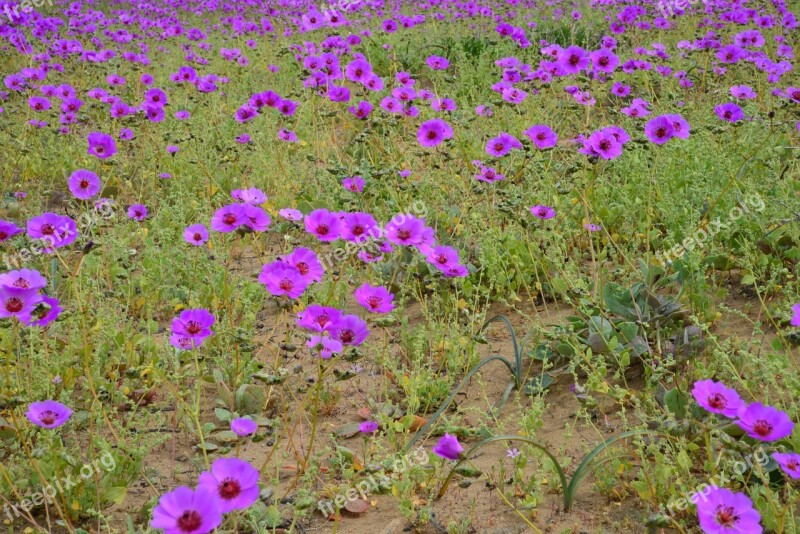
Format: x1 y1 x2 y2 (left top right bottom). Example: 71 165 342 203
197 458 259 514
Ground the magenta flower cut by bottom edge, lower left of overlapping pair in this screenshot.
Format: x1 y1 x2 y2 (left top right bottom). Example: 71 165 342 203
150 486 222 534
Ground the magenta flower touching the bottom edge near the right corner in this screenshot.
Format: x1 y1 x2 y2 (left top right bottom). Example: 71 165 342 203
693 486 763 534
